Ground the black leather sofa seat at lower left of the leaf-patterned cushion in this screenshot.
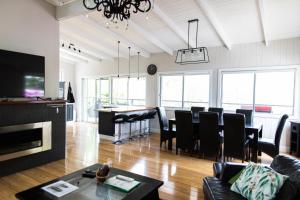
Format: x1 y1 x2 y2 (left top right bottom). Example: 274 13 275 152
203 176 246 200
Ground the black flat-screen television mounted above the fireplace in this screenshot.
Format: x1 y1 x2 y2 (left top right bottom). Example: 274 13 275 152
0 50 45 98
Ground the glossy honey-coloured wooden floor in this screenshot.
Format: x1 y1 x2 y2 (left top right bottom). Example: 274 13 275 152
0 123 272 200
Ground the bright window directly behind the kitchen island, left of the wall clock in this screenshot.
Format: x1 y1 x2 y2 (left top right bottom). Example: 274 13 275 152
112 77 146 106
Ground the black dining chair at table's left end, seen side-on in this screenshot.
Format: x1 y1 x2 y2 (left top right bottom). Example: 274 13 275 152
156 107 176 147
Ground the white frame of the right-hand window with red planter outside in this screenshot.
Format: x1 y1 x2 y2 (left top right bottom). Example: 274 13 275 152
217 65 299 117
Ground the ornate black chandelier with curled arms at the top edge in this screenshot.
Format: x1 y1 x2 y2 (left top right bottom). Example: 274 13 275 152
83 0 152 21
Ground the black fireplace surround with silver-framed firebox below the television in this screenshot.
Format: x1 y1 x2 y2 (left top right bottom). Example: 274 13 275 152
0 101 66 176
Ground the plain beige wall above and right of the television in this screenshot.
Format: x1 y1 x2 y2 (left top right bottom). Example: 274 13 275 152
0 0 59 97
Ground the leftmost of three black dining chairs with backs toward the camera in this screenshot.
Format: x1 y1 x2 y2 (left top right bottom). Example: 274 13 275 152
175 110 196 154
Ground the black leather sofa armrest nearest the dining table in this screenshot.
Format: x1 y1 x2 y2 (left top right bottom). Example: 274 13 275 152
220 162 247 182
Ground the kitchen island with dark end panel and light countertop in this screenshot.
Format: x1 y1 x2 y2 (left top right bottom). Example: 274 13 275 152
97 106 155 140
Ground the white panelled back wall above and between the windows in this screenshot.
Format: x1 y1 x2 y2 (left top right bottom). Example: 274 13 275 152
76 38 300 150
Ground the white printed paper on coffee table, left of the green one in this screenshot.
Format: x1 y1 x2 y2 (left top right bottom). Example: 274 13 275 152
42 181 78 197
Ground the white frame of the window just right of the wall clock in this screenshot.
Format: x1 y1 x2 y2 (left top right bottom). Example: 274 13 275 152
157 70 213 110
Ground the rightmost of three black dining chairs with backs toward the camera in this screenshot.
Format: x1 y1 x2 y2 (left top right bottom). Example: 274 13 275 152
223 113 250 162
